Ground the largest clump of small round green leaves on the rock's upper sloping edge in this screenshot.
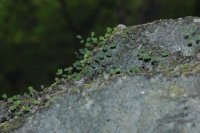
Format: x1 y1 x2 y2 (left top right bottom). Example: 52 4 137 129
56 27 119 82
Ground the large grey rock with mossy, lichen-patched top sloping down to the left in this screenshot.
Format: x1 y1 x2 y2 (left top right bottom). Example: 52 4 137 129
0 17 200 133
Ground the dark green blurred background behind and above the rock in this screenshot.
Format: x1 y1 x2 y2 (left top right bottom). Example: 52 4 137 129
0 0 200 95
